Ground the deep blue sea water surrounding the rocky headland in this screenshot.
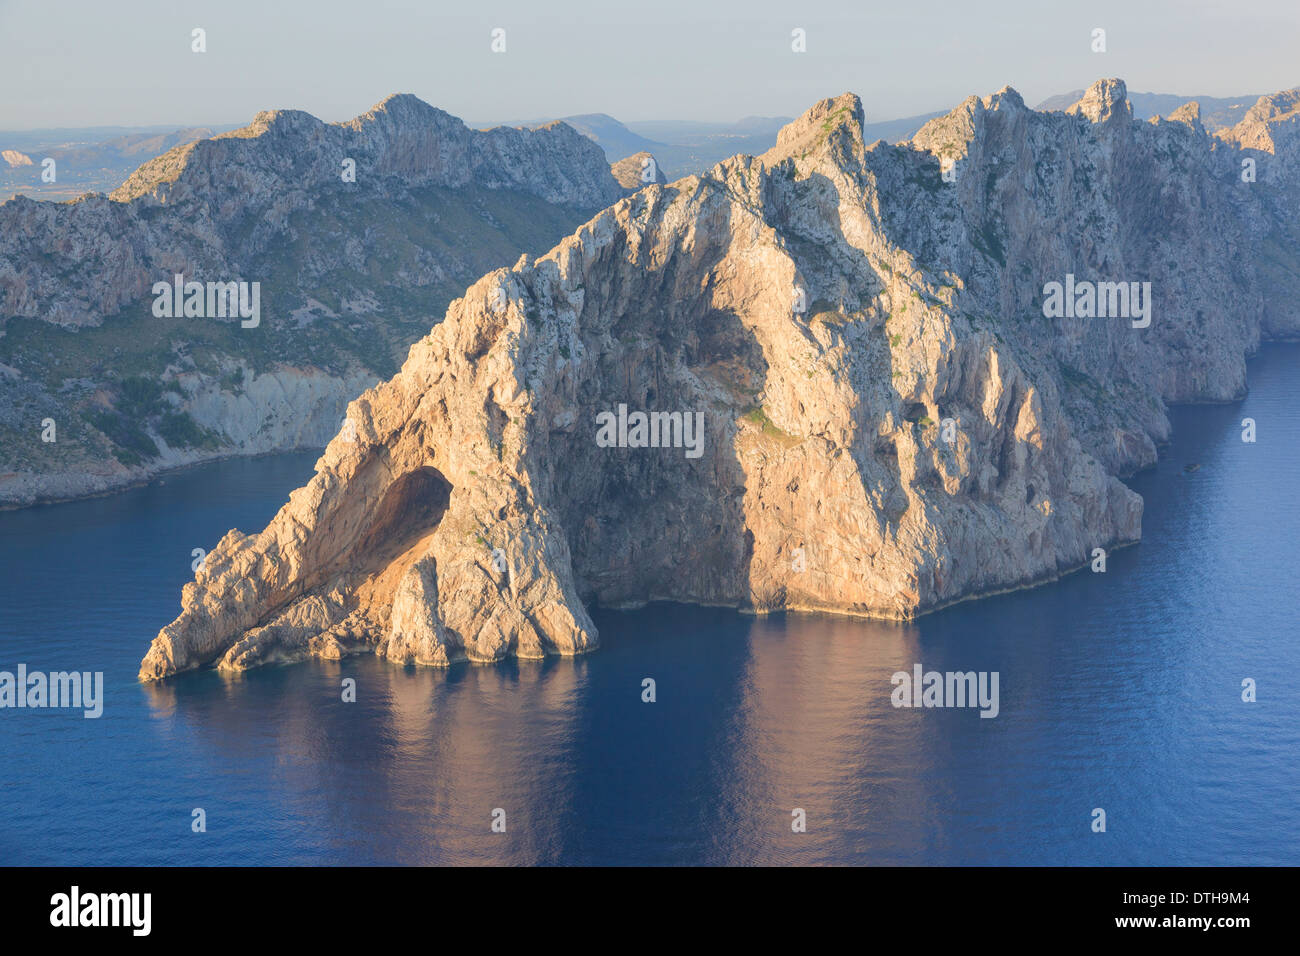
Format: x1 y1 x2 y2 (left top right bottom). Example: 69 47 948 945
0 346 1300 865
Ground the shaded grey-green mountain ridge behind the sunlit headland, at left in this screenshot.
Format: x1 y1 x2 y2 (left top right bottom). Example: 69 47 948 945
0 95 625 505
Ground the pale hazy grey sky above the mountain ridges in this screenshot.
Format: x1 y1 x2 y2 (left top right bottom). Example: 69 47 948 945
0 0 1300 130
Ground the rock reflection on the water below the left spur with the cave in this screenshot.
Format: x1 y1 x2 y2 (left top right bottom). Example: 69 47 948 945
140 658 584 864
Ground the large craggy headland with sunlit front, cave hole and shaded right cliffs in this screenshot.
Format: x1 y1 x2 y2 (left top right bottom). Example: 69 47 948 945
140 81 1297 680
